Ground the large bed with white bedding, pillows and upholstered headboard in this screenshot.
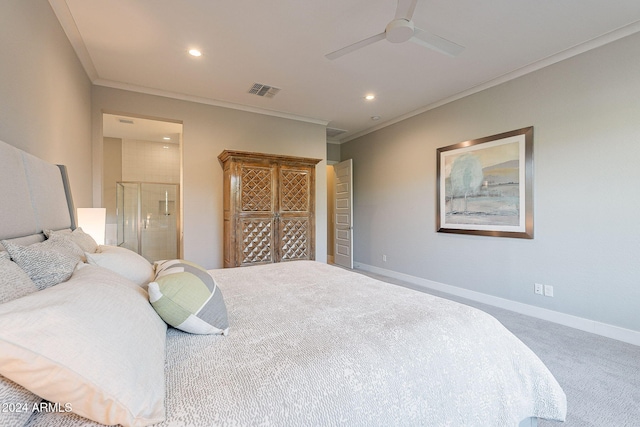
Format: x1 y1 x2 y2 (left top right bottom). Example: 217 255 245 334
0 139 566 427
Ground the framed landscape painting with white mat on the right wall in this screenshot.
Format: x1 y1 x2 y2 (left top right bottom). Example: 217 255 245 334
436 127 533 239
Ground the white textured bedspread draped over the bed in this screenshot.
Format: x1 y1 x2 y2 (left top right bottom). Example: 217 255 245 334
28 261 566 427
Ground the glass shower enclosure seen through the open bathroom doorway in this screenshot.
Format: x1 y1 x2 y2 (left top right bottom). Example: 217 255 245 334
116 182 179 262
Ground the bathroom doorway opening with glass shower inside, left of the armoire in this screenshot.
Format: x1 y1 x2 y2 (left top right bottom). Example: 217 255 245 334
102 113 182 262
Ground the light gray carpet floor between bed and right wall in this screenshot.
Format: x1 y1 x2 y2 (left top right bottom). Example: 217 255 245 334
355 270 640 427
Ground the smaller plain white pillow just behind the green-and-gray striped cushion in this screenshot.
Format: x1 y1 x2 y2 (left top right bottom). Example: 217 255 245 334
85 245 153 286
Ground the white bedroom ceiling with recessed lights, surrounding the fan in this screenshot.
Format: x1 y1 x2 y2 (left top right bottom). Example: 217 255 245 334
49 0 640 141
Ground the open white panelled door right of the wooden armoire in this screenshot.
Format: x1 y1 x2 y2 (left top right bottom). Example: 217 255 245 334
333 159 353 268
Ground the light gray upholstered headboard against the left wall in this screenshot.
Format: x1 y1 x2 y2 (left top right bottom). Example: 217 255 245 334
0 141 76 250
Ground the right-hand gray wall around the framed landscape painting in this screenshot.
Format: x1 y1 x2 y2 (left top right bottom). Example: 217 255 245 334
341 34 640 331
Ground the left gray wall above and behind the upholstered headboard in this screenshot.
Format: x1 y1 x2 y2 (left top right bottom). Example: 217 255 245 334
0 0 92 207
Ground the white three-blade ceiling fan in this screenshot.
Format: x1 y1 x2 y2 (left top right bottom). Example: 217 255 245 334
325 0 464 60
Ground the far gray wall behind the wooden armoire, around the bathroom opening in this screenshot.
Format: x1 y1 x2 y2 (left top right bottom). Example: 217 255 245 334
92 86 327 268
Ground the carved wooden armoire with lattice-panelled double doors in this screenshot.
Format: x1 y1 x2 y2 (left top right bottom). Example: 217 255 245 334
218 150 320 267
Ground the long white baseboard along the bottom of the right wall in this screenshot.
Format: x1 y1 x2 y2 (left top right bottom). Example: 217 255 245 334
354 263 640 346
